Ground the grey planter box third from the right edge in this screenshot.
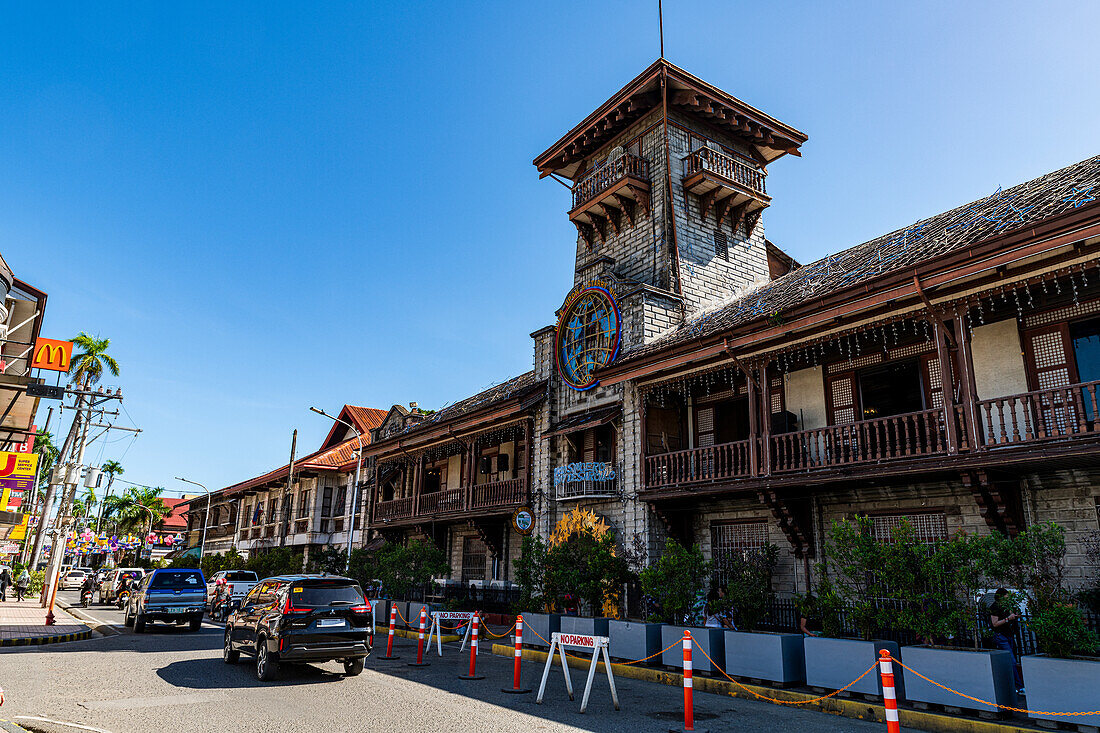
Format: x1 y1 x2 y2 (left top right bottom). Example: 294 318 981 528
802 636 909 700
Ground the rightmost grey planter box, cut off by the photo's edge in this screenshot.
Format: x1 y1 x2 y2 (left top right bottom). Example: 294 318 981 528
1021 654 1100 726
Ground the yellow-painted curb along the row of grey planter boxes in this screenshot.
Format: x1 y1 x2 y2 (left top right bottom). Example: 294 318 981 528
493 644 1035 733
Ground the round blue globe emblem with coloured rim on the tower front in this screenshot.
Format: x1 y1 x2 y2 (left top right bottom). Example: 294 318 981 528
557 285 620 392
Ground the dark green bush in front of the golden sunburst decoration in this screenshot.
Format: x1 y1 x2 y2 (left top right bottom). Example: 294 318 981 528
543 533 630 616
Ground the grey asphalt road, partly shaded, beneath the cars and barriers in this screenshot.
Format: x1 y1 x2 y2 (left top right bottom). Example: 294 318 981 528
0 606 910 733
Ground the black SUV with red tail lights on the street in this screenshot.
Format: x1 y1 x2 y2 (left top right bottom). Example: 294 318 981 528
222 575 374 680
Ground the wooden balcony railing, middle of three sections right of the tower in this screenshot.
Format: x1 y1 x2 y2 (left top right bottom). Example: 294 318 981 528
771 402 947 472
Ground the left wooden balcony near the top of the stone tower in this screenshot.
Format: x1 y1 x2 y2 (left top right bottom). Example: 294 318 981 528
569 153 649 247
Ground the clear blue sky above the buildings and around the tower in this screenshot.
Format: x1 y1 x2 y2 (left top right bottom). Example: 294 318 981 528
0 0 1100 497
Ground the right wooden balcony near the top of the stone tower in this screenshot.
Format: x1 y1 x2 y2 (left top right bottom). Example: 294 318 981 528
683 147 771 231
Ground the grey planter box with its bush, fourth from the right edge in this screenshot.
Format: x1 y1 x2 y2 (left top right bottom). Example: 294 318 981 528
719 545 806 685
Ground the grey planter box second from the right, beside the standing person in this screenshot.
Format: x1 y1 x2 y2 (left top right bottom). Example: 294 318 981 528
895 646 1012 712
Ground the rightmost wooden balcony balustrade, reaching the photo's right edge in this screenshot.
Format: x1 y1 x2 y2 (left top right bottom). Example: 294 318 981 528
977 382 1100 447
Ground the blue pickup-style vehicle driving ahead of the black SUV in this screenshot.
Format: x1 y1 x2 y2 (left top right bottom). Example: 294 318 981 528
124 568 206 634
